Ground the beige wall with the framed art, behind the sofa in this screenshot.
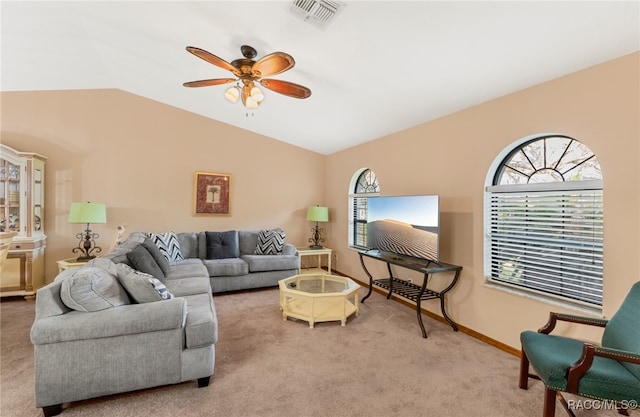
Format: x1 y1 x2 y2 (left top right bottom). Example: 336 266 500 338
1 90 324 281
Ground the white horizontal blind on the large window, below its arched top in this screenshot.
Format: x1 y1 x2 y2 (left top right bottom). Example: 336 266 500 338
485 181 603 306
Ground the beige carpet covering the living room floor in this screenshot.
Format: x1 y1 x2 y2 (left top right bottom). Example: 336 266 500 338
0 289 624 417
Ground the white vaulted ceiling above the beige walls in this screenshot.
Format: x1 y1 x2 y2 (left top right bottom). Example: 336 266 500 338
0 0 640 154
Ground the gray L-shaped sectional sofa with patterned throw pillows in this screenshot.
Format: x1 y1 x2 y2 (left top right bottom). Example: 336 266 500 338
31 230 299 416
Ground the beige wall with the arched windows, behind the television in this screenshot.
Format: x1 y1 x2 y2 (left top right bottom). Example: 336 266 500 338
326 53 640 347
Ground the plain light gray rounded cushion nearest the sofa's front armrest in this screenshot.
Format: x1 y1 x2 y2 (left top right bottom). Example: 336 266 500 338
60 266 131 312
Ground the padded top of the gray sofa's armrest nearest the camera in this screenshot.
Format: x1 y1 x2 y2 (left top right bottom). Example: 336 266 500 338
31 297 187 345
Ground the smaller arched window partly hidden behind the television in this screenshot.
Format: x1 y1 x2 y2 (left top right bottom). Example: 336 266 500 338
349 168 380 248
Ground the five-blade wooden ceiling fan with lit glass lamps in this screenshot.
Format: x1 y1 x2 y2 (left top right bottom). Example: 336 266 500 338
183 45 311 108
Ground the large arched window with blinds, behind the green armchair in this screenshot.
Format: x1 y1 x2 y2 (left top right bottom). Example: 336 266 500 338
485 135 603 306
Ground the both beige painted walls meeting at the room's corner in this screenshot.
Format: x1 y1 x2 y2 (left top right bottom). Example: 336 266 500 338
1 53 640 347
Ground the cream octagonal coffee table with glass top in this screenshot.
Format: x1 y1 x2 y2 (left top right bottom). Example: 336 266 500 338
278 274 360 329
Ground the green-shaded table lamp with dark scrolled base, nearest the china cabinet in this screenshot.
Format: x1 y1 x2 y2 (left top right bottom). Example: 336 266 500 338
69 202 107 262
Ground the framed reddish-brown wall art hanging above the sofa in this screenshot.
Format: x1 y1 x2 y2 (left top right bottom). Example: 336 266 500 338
193 172 231 216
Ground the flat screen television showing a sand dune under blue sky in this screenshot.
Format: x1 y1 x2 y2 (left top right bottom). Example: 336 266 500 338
366 194 440 262
